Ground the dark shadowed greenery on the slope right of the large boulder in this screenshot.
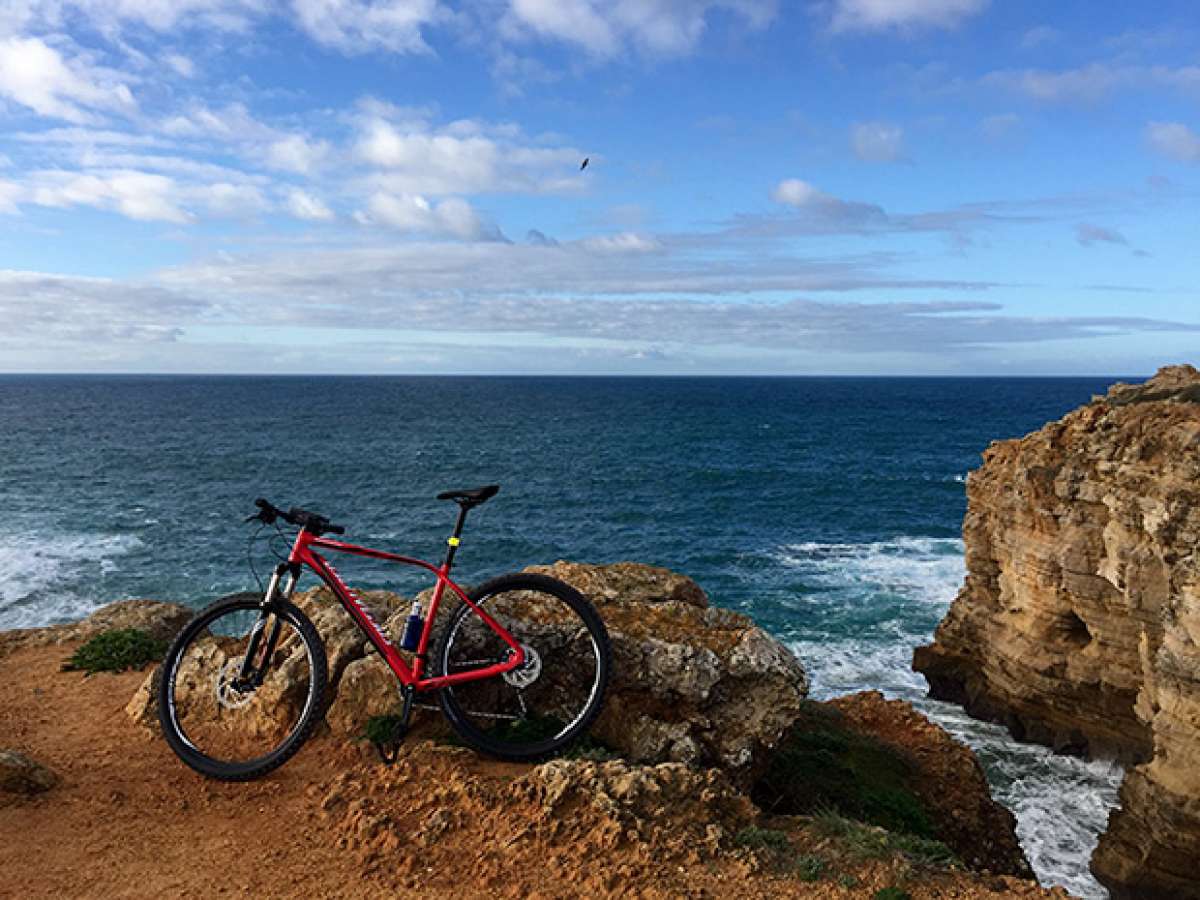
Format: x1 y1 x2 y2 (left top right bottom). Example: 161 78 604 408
750 703 935 838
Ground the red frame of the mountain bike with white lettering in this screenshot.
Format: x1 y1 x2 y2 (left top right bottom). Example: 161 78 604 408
283 528 526 691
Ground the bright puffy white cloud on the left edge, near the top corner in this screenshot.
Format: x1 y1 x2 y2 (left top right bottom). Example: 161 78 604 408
0 37 134 122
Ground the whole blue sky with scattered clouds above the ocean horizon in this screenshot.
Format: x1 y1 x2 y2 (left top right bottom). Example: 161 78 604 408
0 0 1200 374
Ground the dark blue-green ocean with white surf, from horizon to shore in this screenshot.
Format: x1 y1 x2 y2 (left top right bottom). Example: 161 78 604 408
0 376 1121 898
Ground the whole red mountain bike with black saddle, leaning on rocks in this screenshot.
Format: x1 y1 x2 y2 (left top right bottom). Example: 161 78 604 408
158 485 612 781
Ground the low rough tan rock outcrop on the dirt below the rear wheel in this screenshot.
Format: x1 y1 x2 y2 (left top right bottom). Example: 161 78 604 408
324 742 758 868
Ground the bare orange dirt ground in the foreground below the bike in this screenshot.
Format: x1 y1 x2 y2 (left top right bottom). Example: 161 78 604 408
0 646 1064 900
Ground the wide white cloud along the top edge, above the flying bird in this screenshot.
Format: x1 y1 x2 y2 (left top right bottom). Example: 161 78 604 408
508 0 775 56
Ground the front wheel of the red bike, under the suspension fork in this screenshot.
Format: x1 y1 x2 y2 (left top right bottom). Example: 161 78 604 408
158 594 326 781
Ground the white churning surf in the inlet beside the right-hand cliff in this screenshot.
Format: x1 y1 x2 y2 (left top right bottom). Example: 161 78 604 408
773 538 1122 900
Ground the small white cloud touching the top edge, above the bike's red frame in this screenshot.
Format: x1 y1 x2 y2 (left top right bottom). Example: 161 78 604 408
292 0 448 54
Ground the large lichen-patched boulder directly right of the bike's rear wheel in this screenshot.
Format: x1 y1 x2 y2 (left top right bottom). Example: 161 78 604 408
527 562 808 778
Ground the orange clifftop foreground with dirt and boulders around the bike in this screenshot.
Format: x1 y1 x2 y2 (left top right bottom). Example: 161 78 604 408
0 571 1051 900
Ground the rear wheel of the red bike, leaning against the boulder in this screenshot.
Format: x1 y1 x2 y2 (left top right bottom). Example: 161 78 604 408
436 572 612 762
